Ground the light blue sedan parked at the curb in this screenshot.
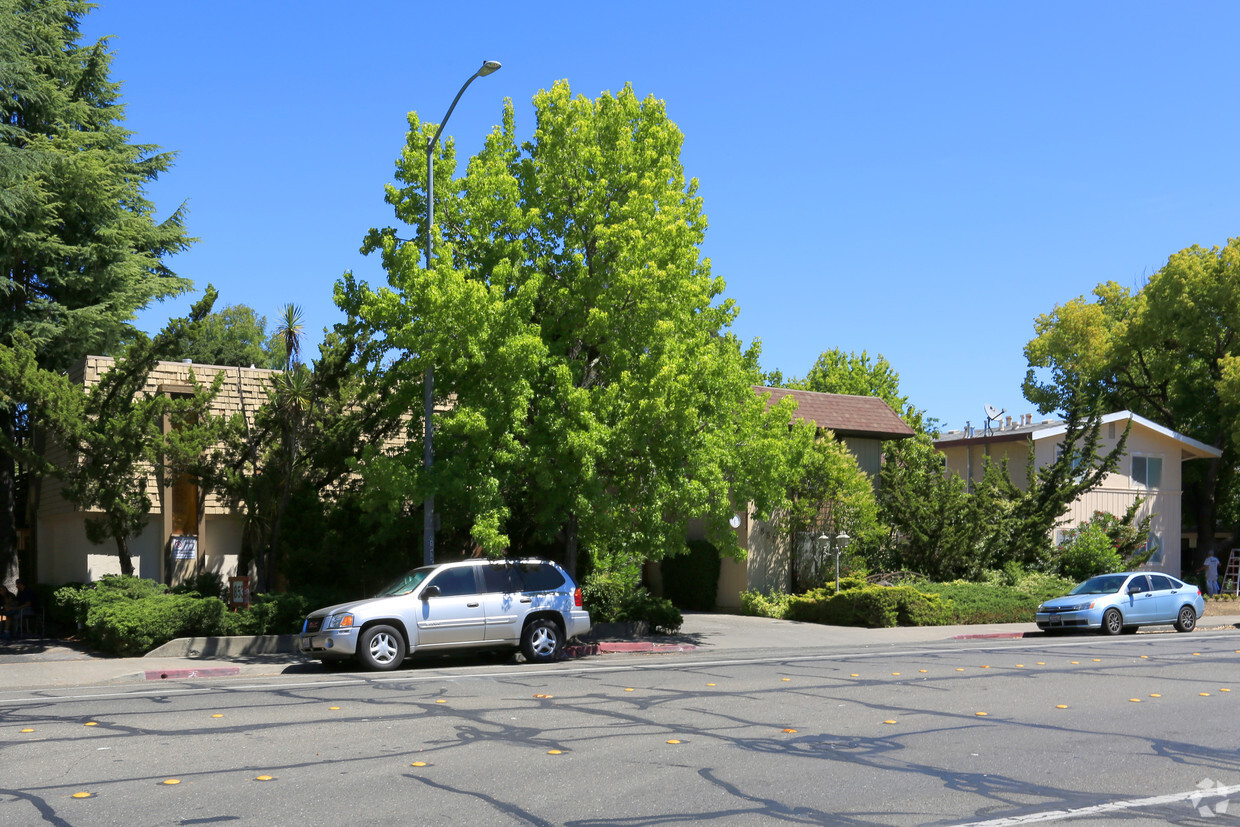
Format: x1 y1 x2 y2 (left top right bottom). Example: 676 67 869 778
1037 572 1205 635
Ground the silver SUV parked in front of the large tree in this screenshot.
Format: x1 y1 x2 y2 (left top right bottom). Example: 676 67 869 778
301 559 590 670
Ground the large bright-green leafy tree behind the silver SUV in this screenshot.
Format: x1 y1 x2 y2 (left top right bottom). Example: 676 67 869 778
337 82 806 575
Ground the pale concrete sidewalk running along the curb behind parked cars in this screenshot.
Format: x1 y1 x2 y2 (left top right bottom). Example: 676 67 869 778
0 614 1240 699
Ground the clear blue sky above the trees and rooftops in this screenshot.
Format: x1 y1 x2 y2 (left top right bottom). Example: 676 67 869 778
83 0 1240 428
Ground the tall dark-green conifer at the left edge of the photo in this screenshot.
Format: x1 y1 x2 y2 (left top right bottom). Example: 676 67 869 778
0 0 192 580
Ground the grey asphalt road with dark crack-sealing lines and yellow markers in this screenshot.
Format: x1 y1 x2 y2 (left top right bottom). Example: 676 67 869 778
0 632 1240 825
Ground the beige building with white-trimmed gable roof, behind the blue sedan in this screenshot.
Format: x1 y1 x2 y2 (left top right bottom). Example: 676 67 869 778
935 410 1221 577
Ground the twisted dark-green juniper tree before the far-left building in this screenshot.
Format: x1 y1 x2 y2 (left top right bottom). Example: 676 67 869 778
0 288 223 575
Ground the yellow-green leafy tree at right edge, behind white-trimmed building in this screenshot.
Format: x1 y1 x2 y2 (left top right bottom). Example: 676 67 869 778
1024 238 1240 565
